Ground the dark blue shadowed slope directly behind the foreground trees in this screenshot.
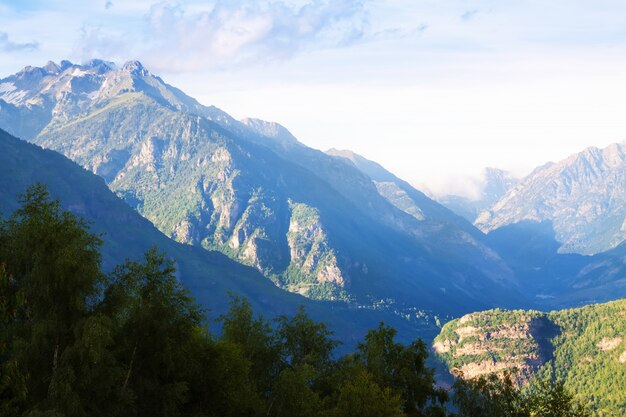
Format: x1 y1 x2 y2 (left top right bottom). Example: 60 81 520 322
0 130 436 349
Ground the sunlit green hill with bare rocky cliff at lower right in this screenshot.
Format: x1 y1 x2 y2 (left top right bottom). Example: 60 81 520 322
433 300 626 416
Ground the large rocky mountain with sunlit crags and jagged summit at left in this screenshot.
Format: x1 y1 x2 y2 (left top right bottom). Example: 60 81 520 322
0 60 524 316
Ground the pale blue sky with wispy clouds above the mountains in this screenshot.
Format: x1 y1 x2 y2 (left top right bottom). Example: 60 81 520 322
0 0 626 197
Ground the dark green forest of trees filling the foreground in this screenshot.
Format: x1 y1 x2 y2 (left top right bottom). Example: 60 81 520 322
0 185 589 417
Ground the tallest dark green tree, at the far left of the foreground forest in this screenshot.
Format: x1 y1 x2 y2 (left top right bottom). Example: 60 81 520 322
0 184 105 416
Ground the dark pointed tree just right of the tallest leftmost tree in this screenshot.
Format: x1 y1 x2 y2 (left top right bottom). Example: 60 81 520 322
103 248 203 416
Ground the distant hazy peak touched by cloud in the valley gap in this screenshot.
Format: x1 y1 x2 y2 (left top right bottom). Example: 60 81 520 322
438 168 519 222
